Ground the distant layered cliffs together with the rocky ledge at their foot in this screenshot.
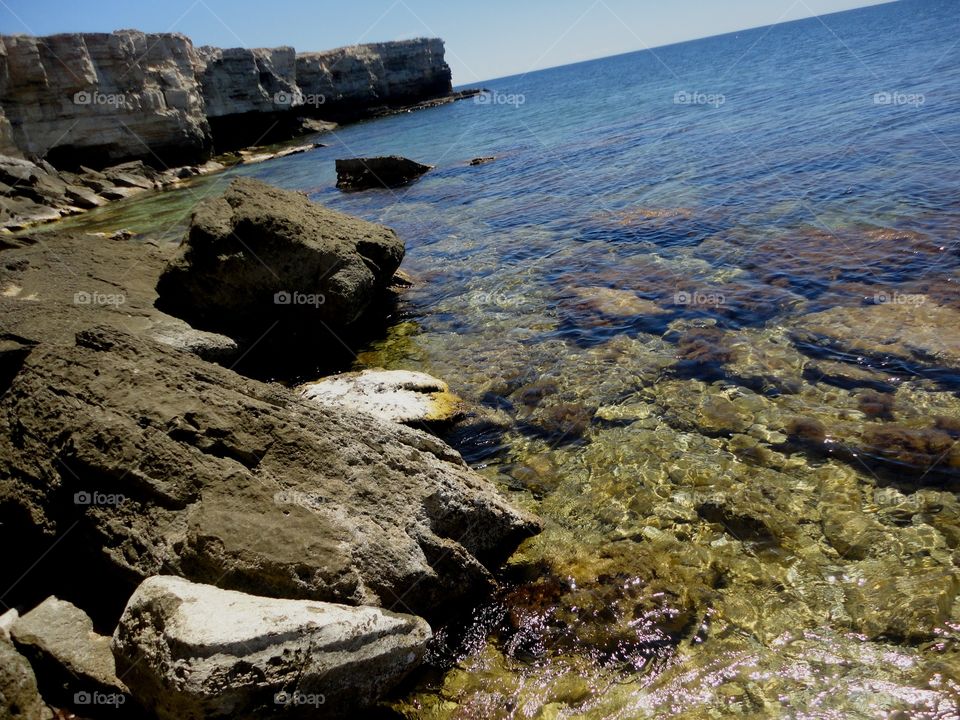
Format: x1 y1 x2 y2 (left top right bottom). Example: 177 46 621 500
0 30 479 232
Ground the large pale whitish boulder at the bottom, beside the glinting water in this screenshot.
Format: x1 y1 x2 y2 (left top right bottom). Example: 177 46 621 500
113 576 431 720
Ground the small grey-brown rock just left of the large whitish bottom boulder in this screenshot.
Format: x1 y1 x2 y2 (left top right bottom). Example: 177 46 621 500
12 597 126 701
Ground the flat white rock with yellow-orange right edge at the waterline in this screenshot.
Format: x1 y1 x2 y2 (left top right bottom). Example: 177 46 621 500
300 370 463 425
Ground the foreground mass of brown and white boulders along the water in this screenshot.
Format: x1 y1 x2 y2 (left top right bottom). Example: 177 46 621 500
0 167 540 720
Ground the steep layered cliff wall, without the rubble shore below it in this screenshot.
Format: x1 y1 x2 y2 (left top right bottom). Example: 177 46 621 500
0 30 451 168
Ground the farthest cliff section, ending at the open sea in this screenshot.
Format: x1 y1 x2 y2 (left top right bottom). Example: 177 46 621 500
297 38 451 111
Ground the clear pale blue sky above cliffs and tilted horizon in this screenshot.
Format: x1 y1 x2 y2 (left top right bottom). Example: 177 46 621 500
0 0 881 85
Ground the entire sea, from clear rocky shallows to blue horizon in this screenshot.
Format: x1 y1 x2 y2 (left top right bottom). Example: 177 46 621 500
47 0 960 718
